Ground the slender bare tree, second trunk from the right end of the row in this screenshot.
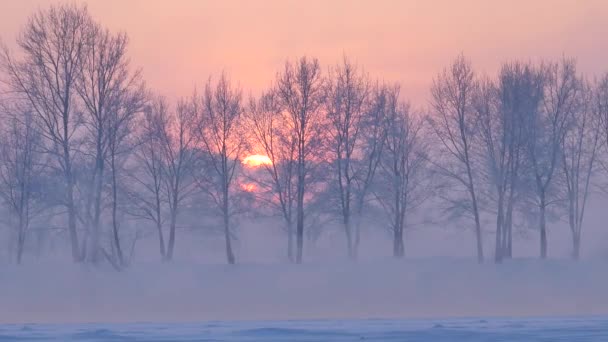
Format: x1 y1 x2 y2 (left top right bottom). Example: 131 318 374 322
526 60 580 259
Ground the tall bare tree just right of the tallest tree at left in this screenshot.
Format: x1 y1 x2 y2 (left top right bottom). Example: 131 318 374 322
76 26 143 263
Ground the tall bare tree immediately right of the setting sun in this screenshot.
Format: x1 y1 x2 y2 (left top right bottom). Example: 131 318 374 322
276 57 324 263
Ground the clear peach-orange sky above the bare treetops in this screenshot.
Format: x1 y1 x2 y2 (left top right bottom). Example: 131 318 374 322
0 0 608 105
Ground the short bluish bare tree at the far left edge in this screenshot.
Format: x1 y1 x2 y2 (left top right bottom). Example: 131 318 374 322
0 103 46 264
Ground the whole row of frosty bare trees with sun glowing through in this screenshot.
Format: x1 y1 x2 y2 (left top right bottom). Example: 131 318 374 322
0 5 608 269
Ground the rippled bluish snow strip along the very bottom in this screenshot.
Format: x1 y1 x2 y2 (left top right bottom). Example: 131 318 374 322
0 317 608 342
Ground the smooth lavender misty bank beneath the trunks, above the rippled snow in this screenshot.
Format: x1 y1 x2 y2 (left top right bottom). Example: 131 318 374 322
0 258 608 323
